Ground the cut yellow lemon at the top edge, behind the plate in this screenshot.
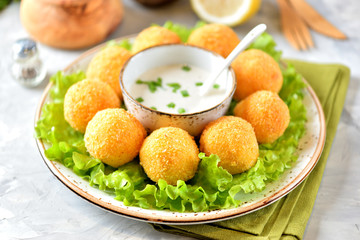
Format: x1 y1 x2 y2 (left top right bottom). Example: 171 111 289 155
191 0 261 26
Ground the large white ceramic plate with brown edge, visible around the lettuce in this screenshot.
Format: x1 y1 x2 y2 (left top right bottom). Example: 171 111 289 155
35 36 325 224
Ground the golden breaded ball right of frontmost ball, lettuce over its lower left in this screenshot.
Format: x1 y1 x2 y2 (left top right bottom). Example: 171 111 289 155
200 116 259 174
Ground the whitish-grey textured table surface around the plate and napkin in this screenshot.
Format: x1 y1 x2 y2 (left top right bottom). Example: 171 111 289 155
0 0 360 240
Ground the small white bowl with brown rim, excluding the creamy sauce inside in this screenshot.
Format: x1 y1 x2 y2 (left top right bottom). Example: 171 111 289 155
120 44 236 136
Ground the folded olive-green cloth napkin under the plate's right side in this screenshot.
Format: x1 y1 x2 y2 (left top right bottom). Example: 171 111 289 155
153 60 350 240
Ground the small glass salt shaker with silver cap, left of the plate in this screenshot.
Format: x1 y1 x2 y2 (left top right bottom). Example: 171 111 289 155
11 38 46 87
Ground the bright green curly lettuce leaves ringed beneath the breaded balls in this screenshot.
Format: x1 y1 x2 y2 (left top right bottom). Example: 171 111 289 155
35 22 306 212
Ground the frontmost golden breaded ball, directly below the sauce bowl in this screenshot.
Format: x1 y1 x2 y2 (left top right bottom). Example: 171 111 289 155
140 127 199 185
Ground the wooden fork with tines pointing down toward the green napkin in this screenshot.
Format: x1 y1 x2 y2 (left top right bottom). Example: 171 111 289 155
277 0 314 50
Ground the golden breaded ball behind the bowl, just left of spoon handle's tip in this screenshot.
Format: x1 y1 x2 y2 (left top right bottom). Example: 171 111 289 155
187 23 240 58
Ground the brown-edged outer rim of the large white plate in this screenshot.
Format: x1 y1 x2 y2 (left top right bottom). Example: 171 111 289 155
34 34 326 225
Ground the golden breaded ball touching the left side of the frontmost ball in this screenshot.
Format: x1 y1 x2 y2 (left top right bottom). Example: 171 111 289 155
84 108 146 168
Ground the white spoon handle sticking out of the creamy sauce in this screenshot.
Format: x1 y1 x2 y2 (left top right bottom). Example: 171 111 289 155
200 23 266 96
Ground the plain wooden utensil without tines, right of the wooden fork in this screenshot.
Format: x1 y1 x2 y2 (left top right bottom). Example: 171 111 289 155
289 0 347 39
